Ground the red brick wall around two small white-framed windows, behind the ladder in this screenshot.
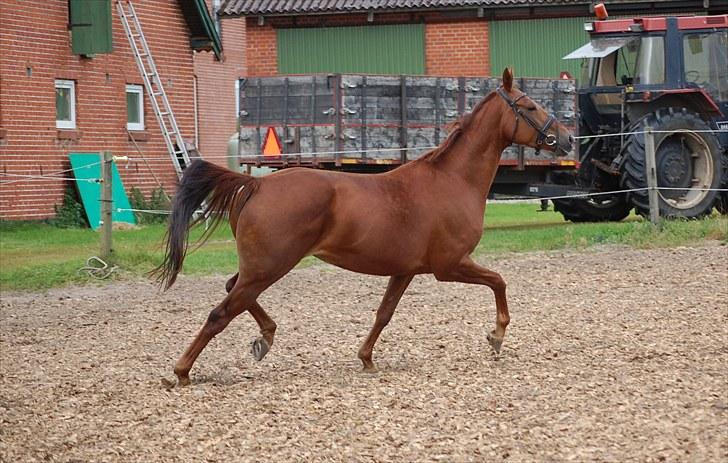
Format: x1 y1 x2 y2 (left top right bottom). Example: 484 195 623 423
0 0 199 219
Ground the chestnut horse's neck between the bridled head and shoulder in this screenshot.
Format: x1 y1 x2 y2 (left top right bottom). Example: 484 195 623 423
440 107 510 197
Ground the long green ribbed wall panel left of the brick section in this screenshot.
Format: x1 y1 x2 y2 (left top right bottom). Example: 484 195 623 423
277 24 425 74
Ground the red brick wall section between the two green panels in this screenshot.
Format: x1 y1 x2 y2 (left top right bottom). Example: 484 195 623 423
425 21 490 76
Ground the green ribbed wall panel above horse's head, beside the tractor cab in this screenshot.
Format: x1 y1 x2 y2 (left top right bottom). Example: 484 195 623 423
489 18 594 78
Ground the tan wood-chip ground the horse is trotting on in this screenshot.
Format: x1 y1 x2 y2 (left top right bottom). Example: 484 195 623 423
0 243 728 462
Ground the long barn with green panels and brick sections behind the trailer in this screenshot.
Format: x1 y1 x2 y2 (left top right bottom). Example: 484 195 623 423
220 0 728 77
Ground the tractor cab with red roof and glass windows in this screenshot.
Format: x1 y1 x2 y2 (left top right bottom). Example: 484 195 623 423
564 15 728 137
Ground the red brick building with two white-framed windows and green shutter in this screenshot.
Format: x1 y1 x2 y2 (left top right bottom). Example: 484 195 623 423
0 0 244 220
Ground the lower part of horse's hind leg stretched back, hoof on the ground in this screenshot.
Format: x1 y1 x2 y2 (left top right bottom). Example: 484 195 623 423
174 285 260 386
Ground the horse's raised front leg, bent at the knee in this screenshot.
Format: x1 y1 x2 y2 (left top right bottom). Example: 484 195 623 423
435 256 511 353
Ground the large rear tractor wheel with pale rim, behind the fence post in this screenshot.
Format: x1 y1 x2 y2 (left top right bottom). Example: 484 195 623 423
622 108 723 219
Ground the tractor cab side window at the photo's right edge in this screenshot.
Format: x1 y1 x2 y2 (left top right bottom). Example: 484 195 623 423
683 31 728 101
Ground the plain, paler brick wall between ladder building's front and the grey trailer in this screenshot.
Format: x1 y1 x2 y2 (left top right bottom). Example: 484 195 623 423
194 8 246 166
